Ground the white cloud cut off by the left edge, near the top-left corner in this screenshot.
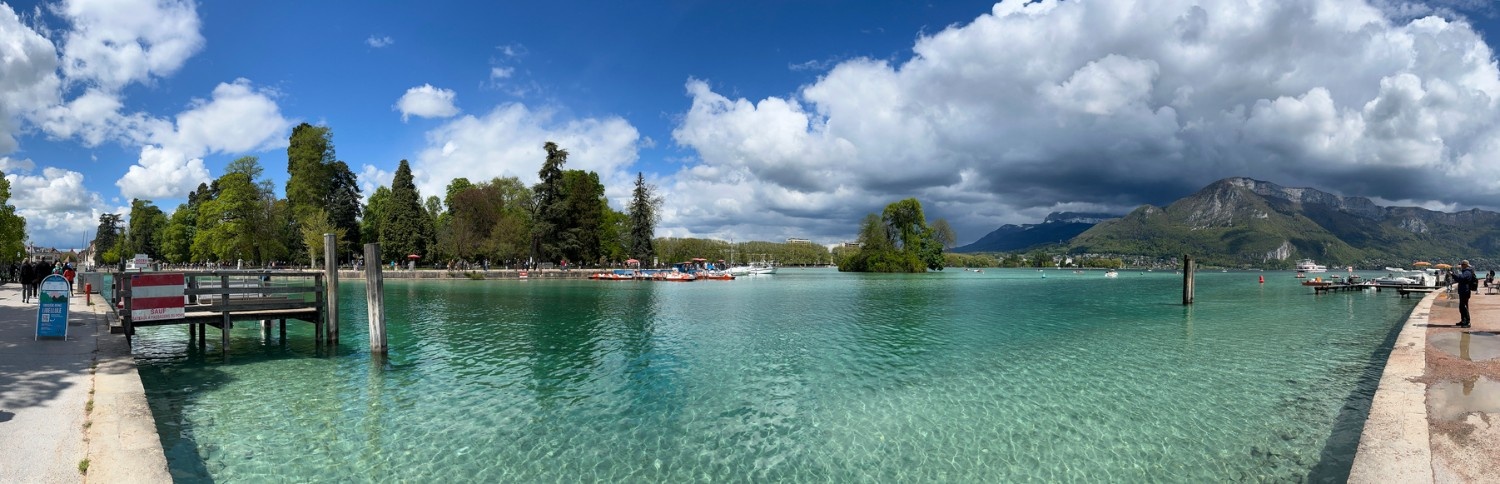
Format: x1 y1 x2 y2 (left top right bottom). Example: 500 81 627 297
0 3 62 154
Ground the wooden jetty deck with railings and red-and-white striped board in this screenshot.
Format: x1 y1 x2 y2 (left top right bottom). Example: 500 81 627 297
110 271 329 351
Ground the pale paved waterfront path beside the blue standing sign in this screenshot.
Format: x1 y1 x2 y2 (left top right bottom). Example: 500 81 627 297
0 283 171 483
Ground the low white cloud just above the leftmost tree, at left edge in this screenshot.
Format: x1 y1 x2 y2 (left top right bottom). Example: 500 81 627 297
0 157 105 249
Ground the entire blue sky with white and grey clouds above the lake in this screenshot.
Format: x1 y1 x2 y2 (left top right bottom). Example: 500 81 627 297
0 0 1500 247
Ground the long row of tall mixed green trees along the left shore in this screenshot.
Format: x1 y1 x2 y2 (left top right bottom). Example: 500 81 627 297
90 123 662 267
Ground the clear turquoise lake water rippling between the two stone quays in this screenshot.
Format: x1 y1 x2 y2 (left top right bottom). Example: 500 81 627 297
135 268 1415 483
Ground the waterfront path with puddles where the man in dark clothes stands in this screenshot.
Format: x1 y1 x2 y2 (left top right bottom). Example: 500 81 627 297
1350 286 1500 483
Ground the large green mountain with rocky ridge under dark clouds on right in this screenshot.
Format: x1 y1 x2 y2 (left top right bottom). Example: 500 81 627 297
1068 178 1500 267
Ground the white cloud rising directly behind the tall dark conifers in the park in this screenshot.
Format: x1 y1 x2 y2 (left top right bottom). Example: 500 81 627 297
414 103 641 198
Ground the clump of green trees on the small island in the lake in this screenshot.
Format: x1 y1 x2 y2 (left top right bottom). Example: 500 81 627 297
839 198 945 273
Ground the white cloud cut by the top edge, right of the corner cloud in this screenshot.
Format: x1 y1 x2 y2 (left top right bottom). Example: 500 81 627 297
54 0 204 91
